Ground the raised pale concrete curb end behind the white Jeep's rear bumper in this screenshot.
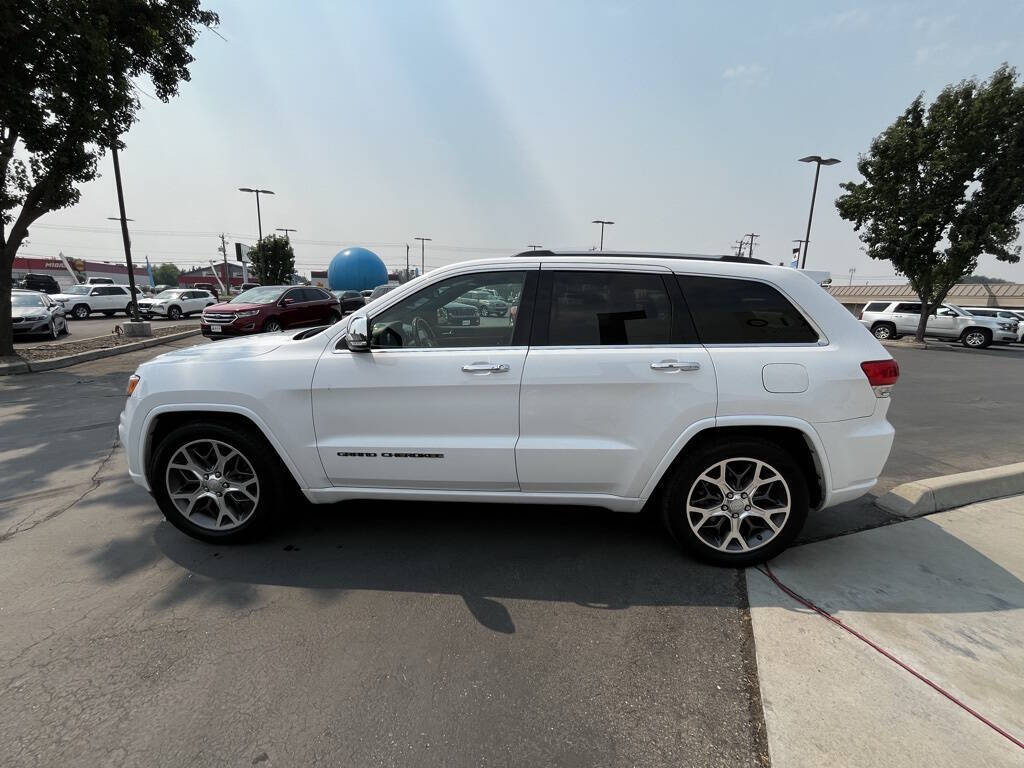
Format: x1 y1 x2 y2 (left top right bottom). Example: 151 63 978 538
874 462 1024 517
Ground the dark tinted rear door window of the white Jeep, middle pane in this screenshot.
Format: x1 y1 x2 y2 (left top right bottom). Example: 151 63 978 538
548 271 673 346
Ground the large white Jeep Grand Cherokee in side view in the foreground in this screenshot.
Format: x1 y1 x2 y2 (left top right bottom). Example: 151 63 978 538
120 251 899 565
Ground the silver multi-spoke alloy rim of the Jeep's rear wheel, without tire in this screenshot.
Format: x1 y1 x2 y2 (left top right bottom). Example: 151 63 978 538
686 457 793 552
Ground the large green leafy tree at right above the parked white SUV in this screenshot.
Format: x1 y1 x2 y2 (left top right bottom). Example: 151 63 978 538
836 66 1024 341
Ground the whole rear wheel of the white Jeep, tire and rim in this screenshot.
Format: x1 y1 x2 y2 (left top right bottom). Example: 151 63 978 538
662 438 809 567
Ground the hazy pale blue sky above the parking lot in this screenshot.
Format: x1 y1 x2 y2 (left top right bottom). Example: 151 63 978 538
24 0 1024 282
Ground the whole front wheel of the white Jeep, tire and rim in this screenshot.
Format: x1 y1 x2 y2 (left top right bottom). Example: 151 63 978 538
150 423 287 543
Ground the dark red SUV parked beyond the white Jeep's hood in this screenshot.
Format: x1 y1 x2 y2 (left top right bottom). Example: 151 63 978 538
200 286 341 339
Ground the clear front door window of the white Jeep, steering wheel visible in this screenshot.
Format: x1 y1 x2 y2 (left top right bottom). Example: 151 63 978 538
370 271 526 349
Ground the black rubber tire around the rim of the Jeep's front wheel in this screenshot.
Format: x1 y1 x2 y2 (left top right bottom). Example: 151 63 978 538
148 422 290 544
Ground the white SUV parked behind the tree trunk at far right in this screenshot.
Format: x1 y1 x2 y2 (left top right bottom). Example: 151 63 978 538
860 301 1017 349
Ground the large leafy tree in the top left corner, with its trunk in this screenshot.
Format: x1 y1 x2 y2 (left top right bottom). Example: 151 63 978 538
0 0 217 355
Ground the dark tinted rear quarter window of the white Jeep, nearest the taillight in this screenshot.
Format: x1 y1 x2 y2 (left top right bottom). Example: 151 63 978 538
679 275 818 344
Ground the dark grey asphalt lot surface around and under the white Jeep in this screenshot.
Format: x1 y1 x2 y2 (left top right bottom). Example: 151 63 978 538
0 339 1024 766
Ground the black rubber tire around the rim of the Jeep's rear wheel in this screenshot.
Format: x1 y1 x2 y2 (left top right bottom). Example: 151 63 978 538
662 437 809 567
